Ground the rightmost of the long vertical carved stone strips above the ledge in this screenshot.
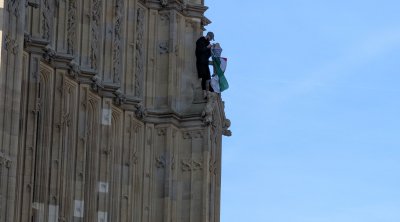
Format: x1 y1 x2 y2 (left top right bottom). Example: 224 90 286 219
135 8 145 97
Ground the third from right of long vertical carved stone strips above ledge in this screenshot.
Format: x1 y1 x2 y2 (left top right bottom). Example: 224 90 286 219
89 0 101 69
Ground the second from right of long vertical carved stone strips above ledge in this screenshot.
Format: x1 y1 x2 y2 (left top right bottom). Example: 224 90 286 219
113 0 123 83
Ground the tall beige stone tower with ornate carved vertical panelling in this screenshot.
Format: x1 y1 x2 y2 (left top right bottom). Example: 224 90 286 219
0 0 230 222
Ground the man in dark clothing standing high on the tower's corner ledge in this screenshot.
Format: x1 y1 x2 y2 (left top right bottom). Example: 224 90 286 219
196 32 214 97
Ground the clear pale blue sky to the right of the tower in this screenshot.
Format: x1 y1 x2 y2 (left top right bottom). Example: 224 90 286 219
206 0 400 222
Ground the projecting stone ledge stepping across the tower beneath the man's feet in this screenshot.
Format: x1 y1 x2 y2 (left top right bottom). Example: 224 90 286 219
20 43 232 136
